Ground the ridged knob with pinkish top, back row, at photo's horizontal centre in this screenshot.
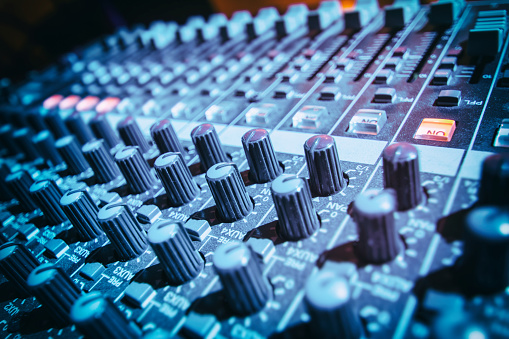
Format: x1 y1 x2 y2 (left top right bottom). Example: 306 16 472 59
242 128 283 183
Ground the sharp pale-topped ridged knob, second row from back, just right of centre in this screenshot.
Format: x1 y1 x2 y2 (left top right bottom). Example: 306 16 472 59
272 174 320 240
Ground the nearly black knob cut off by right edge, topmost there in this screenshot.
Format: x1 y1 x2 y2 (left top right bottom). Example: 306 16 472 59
478 153 509 206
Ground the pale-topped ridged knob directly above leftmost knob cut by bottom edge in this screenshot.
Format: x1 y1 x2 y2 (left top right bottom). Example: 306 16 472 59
97 203 148 261
